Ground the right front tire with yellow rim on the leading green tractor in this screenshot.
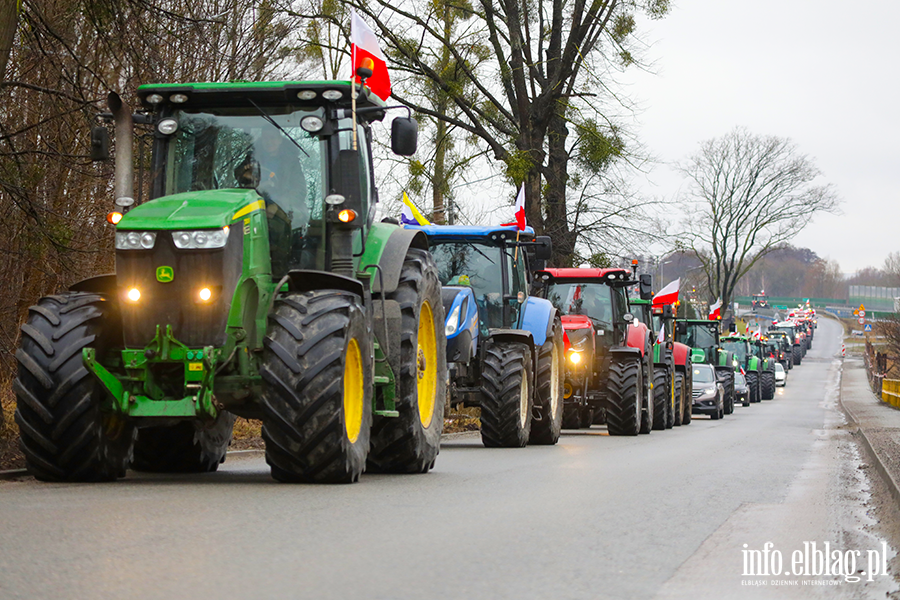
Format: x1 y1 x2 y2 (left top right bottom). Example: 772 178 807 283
260 290 372 483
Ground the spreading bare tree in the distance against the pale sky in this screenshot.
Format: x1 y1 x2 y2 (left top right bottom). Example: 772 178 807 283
679 128 839 307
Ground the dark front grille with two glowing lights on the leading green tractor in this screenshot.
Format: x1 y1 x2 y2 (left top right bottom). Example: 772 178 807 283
116 228 243 348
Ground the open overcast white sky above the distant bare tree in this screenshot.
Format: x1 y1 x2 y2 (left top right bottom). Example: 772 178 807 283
626 0 900 273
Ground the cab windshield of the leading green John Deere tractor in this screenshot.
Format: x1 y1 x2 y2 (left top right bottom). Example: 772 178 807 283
165 106 328 268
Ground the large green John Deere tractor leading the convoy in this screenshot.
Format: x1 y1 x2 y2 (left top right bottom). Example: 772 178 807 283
14 78 447 483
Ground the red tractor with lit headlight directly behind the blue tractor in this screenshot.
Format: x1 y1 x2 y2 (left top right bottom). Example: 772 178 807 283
535 268 654 435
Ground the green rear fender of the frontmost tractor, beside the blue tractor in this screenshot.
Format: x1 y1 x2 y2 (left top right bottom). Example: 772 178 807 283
359 223 428 294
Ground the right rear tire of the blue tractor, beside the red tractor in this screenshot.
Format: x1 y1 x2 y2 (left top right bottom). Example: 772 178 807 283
528 317 564 445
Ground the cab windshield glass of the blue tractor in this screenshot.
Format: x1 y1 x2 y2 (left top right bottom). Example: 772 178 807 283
431 242 503 331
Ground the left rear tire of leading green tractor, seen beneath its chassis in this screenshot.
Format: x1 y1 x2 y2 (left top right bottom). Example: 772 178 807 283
131 410 234 473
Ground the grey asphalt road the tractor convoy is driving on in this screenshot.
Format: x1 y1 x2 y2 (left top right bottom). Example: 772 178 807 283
0 319 894 599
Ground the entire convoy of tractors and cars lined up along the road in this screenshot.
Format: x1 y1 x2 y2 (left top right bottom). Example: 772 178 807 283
14 77 815 483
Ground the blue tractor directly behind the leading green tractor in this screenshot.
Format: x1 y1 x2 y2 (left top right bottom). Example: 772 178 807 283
418 225 564 448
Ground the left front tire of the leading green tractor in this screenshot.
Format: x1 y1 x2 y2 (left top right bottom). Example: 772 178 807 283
12 292 134 481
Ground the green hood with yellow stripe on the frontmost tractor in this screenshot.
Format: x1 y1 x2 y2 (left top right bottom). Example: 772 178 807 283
118 189 265 231
